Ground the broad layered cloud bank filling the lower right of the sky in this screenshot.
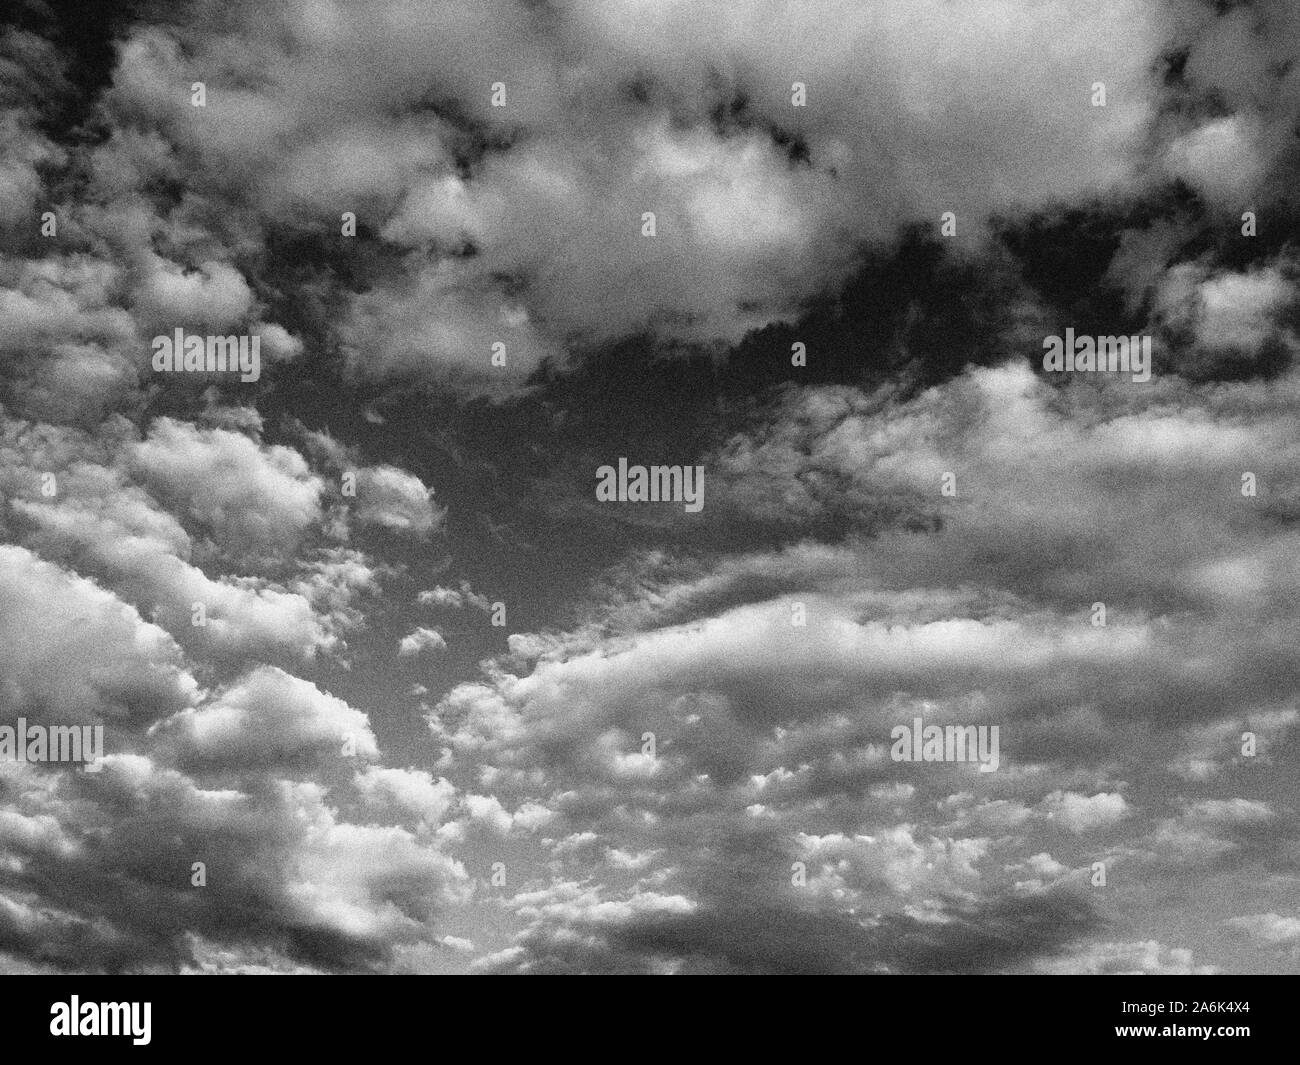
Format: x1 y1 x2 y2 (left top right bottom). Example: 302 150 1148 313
430 363 1300 973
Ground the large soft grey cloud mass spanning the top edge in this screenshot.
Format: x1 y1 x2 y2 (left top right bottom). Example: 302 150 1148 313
73 0 1180 380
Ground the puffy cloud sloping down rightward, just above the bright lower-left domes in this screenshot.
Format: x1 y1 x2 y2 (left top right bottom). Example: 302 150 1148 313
0 420 376 659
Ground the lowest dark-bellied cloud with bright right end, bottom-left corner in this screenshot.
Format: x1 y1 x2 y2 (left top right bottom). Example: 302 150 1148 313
0 756 465 971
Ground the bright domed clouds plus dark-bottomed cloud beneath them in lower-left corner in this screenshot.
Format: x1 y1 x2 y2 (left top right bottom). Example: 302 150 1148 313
0 533 467 970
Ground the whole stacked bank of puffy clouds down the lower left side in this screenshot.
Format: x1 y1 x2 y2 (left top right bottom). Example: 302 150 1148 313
0 361 457 971
